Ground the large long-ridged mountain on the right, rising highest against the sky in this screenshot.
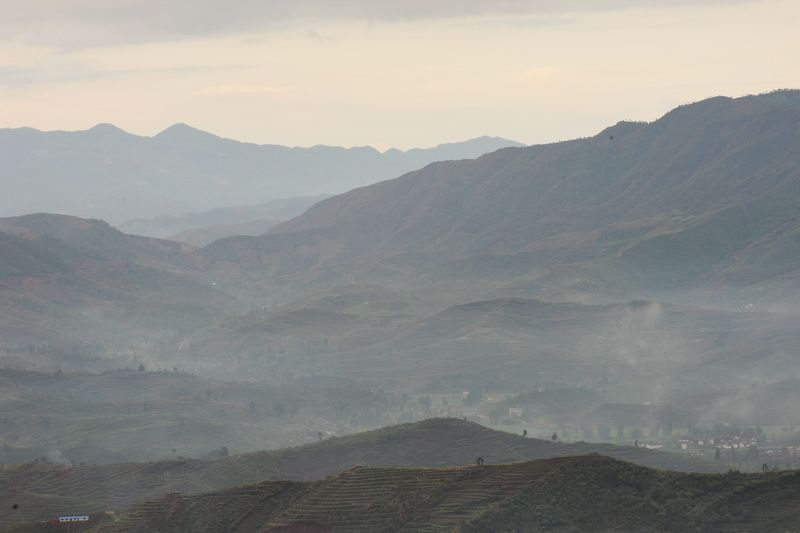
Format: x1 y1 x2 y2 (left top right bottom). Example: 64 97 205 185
204 91 800 309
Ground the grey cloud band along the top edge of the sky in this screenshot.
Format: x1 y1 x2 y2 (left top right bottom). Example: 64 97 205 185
0 0 760 47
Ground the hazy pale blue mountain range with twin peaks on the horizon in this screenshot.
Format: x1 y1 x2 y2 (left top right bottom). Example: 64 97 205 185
0 124 519 224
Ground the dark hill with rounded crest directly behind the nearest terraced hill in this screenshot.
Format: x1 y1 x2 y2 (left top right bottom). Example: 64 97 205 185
0 419 718 526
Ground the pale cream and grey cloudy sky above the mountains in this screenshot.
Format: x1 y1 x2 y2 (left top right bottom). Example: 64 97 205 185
0 0 800 149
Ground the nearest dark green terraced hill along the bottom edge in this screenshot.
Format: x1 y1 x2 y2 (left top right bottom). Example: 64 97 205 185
14 455 800 533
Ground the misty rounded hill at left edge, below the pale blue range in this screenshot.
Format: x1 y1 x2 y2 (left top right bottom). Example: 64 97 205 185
0 213 237 356
